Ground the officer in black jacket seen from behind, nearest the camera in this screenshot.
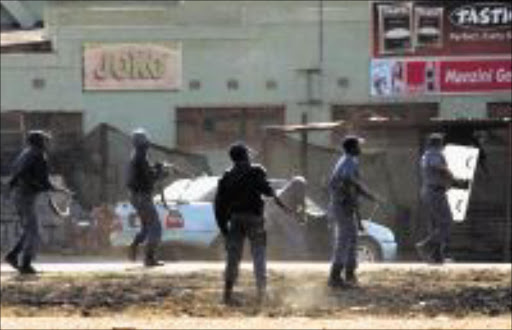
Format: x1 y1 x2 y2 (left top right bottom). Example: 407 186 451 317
214 143 291 305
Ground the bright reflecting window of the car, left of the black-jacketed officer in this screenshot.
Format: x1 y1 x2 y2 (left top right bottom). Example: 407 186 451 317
164 176 219 202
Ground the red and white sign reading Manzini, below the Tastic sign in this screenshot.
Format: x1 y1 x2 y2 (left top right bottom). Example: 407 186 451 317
370 58 512 97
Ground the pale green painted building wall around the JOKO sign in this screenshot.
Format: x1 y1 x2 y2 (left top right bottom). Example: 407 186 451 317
1 1 511 153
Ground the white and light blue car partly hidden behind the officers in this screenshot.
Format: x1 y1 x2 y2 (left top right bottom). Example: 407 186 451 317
110 176 397 262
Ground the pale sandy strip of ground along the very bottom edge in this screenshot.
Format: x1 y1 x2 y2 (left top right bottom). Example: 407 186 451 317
1 316 511 330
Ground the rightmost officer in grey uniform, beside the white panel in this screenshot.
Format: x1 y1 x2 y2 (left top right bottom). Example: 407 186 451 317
416 133 468 263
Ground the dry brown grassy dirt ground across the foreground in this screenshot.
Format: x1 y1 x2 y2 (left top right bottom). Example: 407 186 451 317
1 267 512 329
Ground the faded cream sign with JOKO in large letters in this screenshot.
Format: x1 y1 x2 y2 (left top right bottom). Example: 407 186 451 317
83 42 181 91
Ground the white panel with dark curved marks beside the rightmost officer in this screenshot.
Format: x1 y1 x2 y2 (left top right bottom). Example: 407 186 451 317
443 144 479 222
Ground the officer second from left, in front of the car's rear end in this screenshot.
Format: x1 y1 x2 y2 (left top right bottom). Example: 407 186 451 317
127 128 165 267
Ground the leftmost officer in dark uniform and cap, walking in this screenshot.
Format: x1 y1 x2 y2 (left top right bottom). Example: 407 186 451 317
5 131 55 274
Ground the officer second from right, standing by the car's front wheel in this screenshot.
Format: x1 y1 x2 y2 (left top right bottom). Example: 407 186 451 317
327 136 381 288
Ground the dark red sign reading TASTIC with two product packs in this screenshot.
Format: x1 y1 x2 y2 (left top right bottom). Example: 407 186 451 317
371 0 512 57
